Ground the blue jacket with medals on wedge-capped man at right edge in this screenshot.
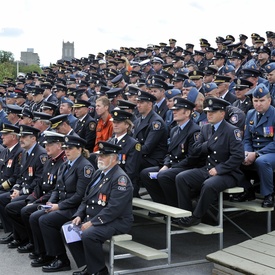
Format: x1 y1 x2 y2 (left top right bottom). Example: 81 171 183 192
244 106 275 154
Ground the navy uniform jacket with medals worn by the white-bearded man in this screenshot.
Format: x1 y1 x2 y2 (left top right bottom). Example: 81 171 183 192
73 165 133 232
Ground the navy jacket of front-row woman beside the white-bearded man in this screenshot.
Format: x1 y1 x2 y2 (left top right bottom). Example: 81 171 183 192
49 155 94 219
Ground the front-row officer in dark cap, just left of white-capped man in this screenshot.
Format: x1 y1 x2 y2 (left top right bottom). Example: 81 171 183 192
0 125 47 248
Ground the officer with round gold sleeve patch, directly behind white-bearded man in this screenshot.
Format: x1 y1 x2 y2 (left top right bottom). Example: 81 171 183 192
108 109 141 195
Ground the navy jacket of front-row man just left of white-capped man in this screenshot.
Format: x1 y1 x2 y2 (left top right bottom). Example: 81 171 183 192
13 143 48 195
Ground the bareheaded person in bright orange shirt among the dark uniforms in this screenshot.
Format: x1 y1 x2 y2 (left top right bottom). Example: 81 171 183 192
93 96 113 152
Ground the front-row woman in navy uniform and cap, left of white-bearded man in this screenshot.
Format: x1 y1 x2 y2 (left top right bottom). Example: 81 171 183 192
30 135 94 272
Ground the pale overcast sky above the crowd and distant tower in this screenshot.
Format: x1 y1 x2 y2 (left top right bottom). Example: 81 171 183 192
0 0 275 66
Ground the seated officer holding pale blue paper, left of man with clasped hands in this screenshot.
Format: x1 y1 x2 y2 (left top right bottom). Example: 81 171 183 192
140 97 204 207
